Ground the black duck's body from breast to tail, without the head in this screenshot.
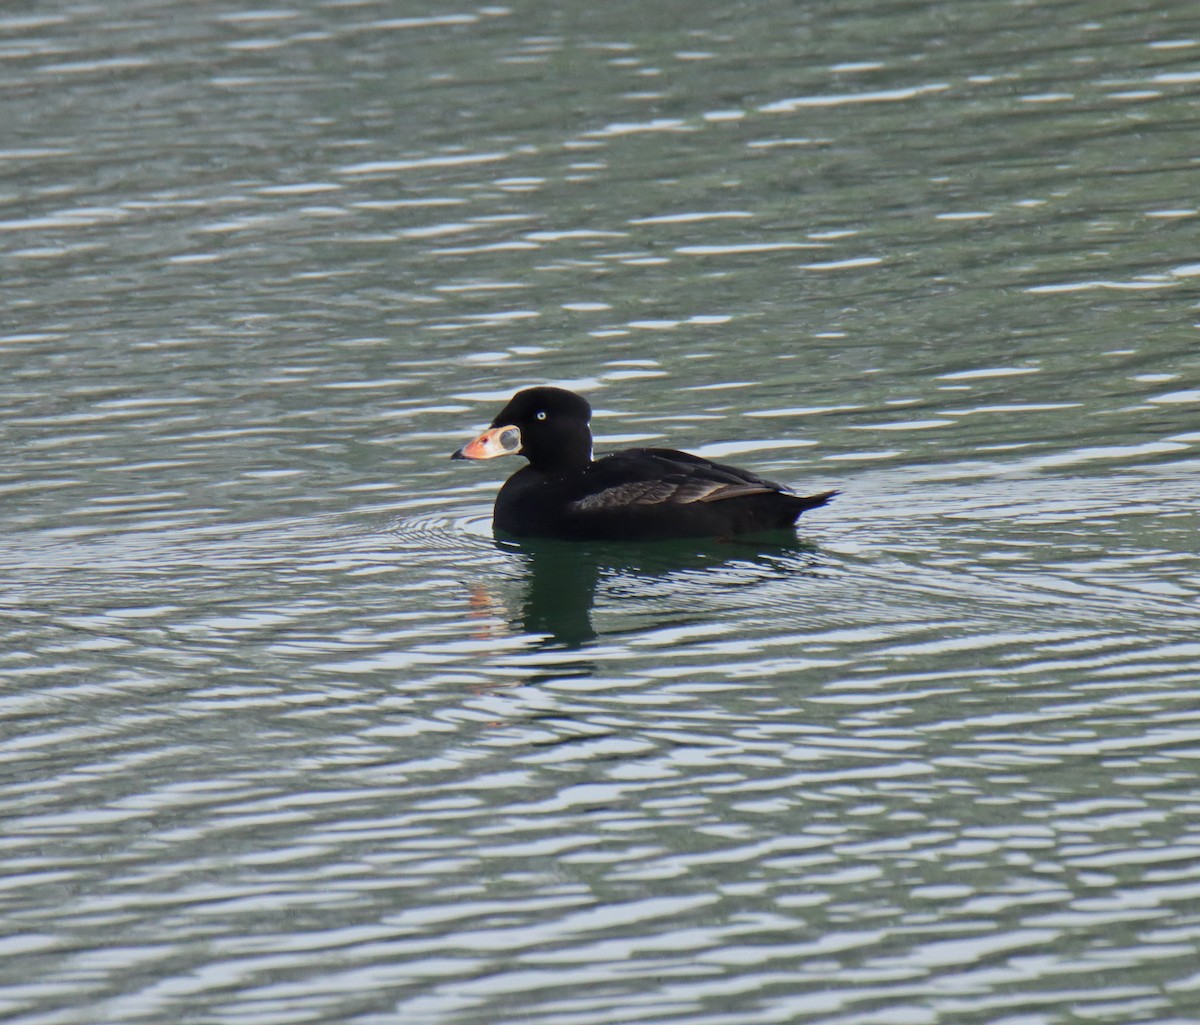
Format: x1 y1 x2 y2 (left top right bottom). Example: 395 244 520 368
494 449 834 541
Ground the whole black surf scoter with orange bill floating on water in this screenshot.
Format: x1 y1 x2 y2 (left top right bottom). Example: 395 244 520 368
451 388 838 541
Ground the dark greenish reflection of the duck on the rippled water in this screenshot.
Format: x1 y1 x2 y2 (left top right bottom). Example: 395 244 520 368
496 532 818 649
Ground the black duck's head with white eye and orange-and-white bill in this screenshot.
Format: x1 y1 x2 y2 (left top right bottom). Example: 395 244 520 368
451 388 592 473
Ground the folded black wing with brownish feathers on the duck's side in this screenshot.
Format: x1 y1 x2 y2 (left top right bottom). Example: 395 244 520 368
572 449 788 513
